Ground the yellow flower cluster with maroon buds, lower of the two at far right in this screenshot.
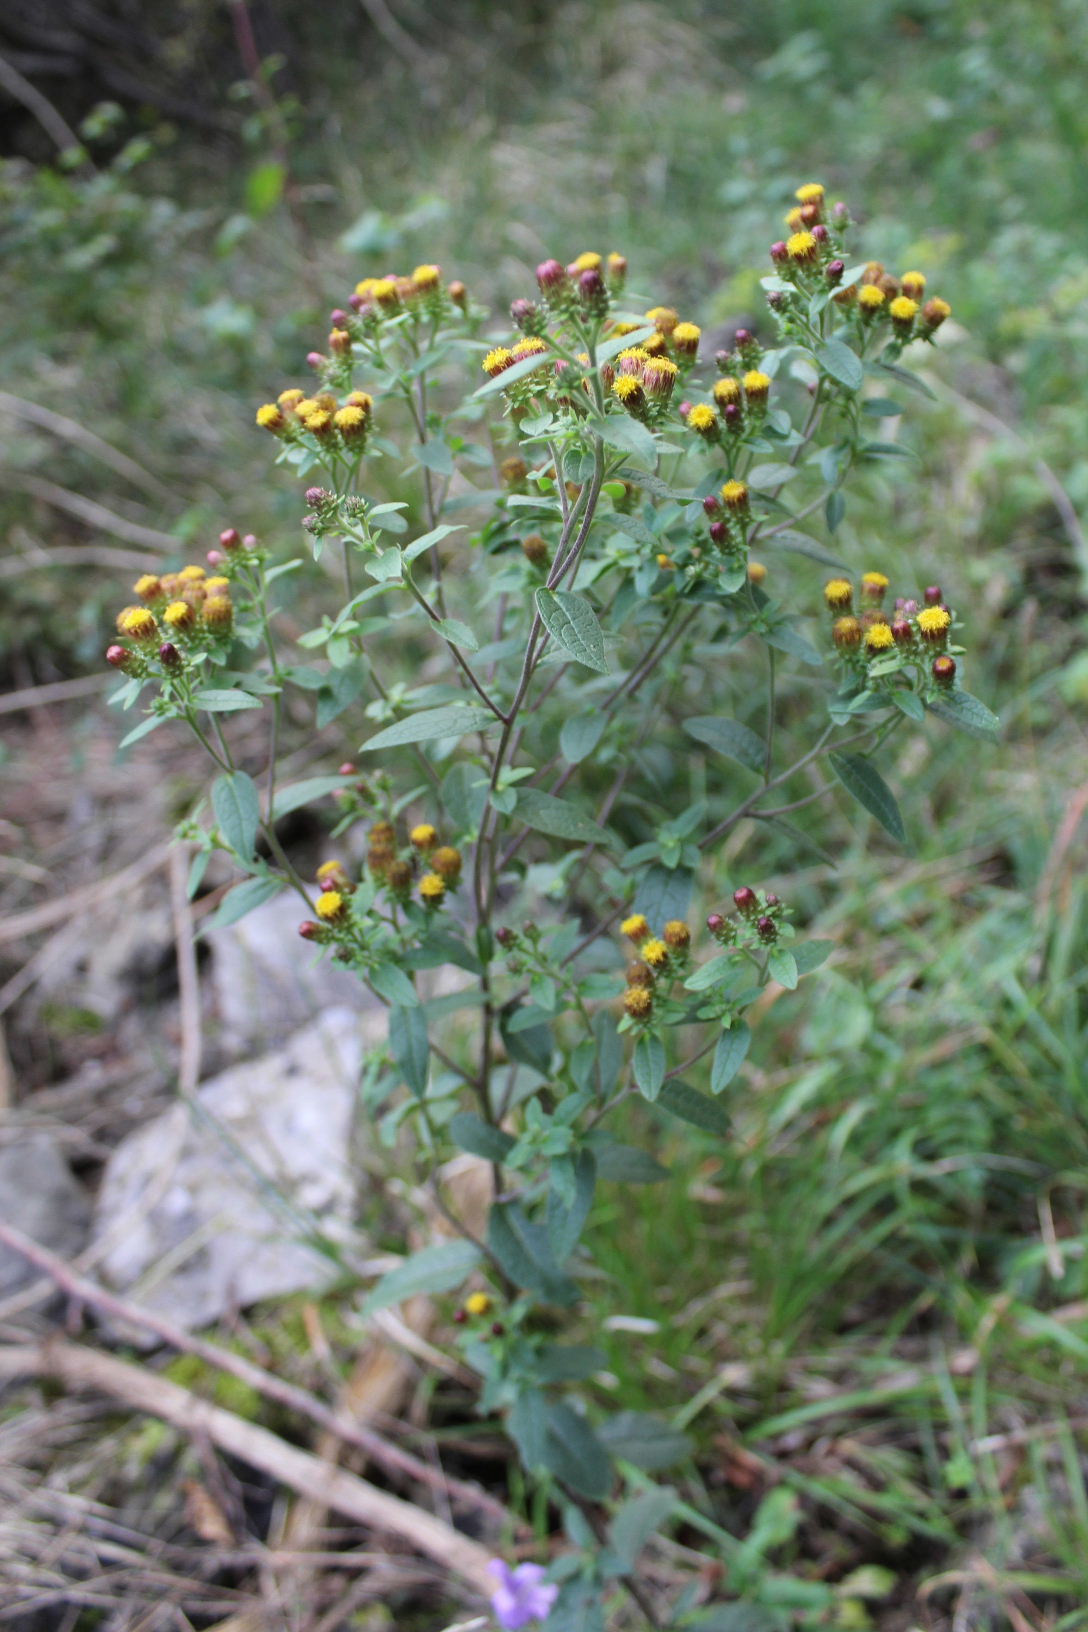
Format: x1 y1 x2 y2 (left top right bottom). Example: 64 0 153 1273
824 573 962 692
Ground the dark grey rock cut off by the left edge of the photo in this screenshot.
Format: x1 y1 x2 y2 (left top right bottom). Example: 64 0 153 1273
0 1133 91 1297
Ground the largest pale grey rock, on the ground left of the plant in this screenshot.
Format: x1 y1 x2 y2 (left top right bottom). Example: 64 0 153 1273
93 1009 385 1327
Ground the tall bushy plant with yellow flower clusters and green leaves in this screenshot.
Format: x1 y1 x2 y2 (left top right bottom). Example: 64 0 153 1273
108 184 997 1629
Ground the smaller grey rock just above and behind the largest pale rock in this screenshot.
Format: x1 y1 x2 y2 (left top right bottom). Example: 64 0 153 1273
207 891 375 1056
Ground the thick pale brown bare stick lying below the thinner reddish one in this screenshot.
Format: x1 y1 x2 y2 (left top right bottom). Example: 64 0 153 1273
0 1338 494 1594
